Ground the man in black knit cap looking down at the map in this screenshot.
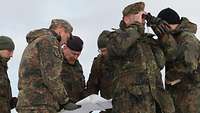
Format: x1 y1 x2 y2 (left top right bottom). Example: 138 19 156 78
61 36 86 103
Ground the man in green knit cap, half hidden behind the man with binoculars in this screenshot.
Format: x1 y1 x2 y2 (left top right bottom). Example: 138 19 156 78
87 31 114 113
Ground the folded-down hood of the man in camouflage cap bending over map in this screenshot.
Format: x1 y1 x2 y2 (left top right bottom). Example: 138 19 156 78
26 28 52 44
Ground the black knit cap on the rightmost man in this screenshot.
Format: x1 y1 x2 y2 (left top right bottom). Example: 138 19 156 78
157 8 180 24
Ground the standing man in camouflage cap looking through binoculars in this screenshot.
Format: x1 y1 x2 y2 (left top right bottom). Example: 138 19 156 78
108 2 173 113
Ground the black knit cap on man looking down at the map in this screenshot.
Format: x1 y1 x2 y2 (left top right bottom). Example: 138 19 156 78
67 36 83 52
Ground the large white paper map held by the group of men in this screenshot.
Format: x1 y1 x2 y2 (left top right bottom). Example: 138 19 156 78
60 94 112 113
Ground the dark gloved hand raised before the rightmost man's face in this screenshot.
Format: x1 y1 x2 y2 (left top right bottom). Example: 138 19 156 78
143 13 170 36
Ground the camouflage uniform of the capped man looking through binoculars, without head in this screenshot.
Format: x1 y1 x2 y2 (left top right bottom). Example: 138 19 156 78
108 20 160 113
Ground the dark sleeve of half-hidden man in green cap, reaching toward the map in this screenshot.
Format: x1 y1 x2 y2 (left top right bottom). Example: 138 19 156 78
87 58 101 95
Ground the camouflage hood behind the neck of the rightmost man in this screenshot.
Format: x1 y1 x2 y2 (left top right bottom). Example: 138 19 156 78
175 17 197 34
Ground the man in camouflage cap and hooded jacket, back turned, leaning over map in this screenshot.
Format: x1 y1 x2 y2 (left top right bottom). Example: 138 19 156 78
17 19 80 113
